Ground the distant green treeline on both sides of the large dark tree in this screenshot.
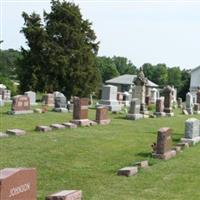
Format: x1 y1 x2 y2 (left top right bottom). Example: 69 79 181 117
0 49 191 99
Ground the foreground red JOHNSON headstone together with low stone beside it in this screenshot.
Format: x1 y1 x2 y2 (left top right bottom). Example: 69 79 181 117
0 168 83 200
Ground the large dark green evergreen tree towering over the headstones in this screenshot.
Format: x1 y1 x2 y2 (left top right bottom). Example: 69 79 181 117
19 0 100 97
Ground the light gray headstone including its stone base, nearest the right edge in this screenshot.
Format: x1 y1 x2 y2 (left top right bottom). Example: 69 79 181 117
181 118 200 144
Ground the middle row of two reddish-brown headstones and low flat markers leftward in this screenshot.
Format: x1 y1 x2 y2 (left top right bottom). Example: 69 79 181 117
0 97 111 137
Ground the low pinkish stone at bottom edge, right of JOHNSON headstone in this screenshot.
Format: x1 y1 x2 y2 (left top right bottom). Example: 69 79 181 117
45 190 82 200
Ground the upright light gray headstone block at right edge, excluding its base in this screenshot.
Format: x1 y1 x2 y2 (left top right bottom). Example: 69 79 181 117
185 118 199 139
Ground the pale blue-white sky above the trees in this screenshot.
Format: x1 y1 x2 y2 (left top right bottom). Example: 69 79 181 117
0 0 200 69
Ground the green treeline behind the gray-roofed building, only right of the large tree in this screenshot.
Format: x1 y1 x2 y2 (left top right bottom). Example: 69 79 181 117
97 56 191 99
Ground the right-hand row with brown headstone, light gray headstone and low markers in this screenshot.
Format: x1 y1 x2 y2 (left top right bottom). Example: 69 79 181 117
118 118 200 176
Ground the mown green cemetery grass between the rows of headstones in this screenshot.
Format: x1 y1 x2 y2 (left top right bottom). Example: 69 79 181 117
0 105 200 200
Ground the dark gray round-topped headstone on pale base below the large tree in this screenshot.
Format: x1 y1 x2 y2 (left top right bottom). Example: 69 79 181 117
53 93 68 112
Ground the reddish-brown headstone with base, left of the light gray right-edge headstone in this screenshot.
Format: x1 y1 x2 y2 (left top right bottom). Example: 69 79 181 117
153 127 176 160
